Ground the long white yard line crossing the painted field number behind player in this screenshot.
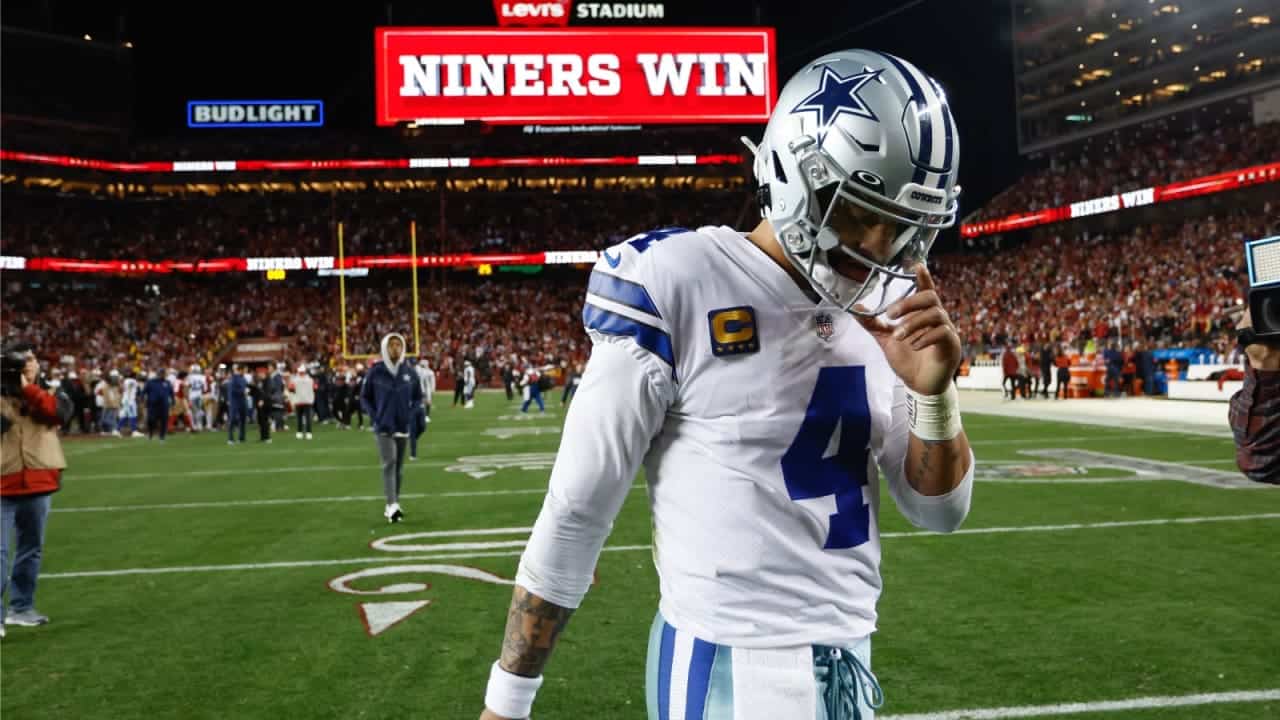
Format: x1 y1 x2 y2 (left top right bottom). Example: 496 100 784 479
40 512 1280 580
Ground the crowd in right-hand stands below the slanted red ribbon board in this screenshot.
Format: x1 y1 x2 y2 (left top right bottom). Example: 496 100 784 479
932 202 1280 355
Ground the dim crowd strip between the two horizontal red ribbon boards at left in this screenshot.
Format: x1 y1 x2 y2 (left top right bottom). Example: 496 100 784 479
0 191 753 260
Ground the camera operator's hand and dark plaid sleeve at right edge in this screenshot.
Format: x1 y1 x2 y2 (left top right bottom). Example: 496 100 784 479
1230 309 1280 484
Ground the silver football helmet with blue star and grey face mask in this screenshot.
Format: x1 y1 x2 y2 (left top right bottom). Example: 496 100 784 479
744 50 960 315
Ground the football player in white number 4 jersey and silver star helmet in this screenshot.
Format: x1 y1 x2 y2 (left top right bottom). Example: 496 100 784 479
481 50 974 720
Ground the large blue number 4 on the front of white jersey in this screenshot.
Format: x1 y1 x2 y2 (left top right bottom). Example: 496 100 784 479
782 365 872 550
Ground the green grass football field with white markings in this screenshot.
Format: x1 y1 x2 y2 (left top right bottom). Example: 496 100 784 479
0 393 1280 720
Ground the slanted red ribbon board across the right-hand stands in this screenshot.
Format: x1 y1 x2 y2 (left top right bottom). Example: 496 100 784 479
960 163 1280 237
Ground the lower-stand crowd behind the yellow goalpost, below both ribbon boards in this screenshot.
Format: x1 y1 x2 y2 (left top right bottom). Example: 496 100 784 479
0 272 588 397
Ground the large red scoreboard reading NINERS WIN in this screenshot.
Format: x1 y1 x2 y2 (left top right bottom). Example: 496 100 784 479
374 28 777 126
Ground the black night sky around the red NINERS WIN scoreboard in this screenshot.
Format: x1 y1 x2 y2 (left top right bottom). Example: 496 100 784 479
4 0 1019 211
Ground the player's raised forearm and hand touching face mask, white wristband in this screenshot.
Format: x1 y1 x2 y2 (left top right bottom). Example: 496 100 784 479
859 265 974 532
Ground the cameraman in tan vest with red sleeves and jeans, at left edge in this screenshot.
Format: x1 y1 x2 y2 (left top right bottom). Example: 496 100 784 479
0 345 74 625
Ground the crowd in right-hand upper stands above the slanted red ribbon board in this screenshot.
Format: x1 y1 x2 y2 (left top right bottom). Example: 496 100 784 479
966 120 1280 222
